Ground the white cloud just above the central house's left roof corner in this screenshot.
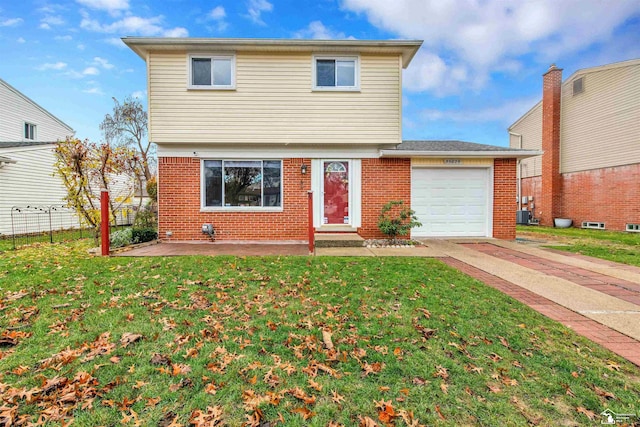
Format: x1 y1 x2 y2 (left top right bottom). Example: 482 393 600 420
80 13 189 37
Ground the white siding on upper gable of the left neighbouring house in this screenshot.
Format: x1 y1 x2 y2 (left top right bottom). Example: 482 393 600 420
0 81 73 142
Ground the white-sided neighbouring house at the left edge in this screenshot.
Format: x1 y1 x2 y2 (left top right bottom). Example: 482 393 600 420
0 79 75 235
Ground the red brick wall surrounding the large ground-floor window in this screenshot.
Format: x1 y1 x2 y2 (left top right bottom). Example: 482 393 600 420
158 157 311 240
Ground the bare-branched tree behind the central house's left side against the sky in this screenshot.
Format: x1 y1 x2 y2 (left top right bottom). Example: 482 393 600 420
100 96 153 182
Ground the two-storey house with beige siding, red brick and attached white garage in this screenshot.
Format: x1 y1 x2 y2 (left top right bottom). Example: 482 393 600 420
123 37 538 240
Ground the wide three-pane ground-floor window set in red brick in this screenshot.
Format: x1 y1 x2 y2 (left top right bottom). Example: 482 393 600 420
203 160 282 208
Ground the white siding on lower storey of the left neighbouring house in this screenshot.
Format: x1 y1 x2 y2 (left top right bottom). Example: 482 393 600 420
0 144 66 234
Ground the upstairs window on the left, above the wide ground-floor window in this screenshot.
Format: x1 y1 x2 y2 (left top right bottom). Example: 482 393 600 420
189 55 236 89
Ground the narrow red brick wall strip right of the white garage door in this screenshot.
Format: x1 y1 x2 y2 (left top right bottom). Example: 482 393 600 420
493 159 518 240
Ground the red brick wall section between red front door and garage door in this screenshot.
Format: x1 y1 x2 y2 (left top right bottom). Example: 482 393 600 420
358 159 411 239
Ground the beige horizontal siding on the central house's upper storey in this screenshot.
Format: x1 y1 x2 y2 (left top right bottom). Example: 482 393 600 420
148 52 401 144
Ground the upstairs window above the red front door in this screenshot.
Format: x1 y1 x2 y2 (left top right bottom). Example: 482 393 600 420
313 57 360 90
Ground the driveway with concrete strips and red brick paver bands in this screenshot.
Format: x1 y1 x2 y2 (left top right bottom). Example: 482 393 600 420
427 240 640 366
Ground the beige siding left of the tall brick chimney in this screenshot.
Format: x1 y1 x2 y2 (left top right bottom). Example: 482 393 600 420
509 103 542 178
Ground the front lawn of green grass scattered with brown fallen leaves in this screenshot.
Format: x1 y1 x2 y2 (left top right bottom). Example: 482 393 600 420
0 242 640 426
